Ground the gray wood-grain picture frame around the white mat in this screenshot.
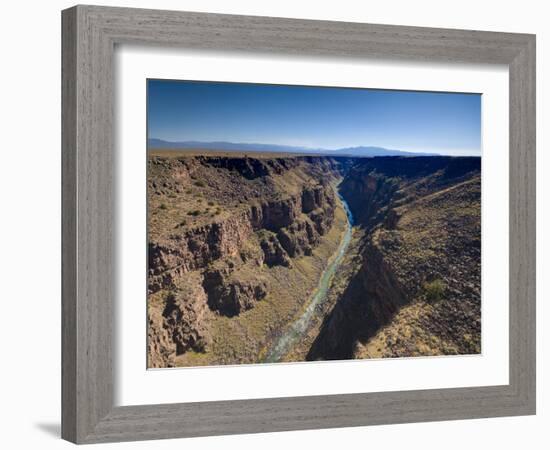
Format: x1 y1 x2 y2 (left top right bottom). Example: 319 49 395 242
62 6 536 443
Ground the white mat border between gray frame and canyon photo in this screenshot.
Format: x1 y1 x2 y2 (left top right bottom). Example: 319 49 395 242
114 46 509 405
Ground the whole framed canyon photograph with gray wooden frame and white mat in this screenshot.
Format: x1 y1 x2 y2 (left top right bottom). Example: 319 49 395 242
62 6 536 443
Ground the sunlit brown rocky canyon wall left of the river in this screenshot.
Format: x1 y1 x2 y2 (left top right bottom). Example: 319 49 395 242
148 156 343 367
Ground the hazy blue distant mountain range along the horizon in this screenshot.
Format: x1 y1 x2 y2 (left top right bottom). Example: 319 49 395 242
147 138 439 157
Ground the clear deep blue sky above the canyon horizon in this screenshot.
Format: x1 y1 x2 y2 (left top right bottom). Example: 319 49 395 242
147 80 481 155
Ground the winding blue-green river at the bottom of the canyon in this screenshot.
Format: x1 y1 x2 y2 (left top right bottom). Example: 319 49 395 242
263 189 353 363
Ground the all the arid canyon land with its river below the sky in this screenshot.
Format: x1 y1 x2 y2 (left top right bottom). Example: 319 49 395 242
147 150 481 368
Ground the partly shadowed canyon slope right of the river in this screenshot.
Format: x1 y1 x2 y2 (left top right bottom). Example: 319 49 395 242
308 157 481 360
